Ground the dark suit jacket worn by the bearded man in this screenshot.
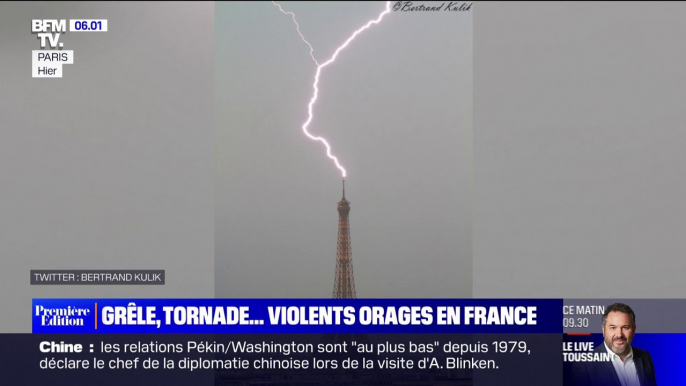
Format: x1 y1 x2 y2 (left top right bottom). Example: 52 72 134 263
571 343 657 386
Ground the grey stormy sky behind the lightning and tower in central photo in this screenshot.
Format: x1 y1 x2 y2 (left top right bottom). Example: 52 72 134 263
214 2 472 298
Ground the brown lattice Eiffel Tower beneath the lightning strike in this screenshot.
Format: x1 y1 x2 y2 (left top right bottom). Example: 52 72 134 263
322 180 369 343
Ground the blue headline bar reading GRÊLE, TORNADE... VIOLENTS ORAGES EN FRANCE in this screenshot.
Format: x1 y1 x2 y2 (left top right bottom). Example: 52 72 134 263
31 299 563 334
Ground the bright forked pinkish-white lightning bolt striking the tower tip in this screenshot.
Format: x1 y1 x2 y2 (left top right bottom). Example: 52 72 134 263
272 1 391 178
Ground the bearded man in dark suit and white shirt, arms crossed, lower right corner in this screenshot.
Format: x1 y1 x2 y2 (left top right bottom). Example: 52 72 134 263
572 303 657 386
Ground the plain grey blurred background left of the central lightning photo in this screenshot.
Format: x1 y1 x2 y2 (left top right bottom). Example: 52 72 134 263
0 1 214 333
